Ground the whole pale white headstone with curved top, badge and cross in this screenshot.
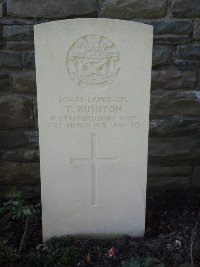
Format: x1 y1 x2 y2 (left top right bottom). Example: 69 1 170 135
35 19 153 240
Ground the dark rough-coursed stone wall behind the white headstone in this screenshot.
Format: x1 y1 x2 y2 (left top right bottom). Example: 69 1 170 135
0 0 200 197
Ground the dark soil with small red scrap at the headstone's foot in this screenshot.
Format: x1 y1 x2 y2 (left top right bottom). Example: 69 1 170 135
1 192 200 267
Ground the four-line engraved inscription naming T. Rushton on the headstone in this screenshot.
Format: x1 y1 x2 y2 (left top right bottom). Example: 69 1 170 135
48 96 140 130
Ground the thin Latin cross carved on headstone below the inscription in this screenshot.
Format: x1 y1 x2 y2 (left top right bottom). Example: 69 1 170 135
70 134 117 207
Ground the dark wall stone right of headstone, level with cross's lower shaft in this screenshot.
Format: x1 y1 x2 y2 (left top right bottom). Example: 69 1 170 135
147 177 190 191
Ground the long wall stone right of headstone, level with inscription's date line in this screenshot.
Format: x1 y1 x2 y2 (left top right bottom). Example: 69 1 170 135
149 119 200 137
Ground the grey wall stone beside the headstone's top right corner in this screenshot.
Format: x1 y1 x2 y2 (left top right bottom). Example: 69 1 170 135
152 20 193 35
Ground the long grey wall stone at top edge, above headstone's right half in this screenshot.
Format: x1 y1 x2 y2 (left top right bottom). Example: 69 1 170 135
99 0 167 19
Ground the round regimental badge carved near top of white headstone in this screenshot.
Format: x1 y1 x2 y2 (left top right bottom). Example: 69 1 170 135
67 34 120 86
